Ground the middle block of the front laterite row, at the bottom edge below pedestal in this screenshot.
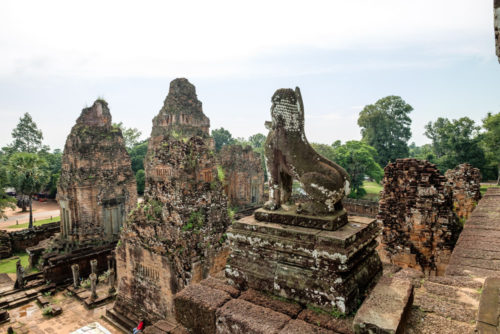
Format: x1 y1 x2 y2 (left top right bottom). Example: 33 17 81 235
216 299 291 334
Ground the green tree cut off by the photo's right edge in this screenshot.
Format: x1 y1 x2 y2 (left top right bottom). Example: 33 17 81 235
482 113 500 185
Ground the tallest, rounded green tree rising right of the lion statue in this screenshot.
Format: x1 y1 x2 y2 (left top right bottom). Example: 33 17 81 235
358 96 413 166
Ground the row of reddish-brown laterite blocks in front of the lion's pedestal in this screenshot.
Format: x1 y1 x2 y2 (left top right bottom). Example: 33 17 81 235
174 278 353 334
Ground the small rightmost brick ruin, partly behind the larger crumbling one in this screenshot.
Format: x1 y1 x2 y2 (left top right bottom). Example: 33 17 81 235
444 163 481 222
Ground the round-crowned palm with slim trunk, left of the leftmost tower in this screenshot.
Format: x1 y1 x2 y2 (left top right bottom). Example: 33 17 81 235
8 152 49 228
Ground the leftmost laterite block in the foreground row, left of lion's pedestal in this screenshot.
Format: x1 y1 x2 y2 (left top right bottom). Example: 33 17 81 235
174 284 231 334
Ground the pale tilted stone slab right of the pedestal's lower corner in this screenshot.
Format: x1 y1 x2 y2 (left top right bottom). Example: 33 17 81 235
353 277 413 334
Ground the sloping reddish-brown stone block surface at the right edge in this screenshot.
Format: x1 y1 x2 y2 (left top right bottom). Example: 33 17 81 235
446 188 500 278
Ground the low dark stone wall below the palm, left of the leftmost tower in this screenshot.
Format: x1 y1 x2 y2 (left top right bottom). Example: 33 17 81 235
9 222 61 252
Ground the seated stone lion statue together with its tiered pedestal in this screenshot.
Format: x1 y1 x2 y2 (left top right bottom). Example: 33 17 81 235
226 88 382 312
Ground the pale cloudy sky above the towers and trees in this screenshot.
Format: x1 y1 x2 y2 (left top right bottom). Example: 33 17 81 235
0 0 500 148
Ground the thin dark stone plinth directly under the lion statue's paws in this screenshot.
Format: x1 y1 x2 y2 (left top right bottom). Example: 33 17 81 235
254 208 347 231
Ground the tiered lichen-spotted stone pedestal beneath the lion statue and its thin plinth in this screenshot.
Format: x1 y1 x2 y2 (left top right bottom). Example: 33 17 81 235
226 209 382 313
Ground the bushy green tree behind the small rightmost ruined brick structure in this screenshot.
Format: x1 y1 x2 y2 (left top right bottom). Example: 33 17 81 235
425 117 486 173
